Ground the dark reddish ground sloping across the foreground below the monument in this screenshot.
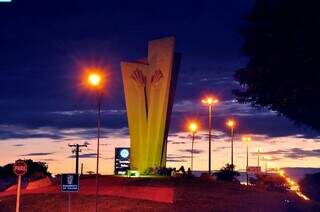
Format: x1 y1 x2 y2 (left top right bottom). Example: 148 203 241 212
0 176 320 212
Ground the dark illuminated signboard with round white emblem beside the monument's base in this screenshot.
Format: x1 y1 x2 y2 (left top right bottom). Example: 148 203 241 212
114 147 130 175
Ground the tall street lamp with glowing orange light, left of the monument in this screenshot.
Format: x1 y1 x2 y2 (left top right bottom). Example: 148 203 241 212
87 71 103 212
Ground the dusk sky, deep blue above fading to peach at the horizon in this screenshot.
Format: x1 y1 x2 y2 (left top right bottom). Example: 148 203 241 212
0 0 320 173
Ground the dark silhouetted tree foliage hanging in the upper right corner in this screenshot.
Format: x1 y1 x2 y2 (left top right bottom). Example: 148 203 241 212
234 0 320 130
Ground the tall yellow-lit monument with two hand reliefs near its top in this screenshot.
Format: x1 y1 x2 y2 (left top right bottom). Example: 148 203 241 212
121 37 180 172
